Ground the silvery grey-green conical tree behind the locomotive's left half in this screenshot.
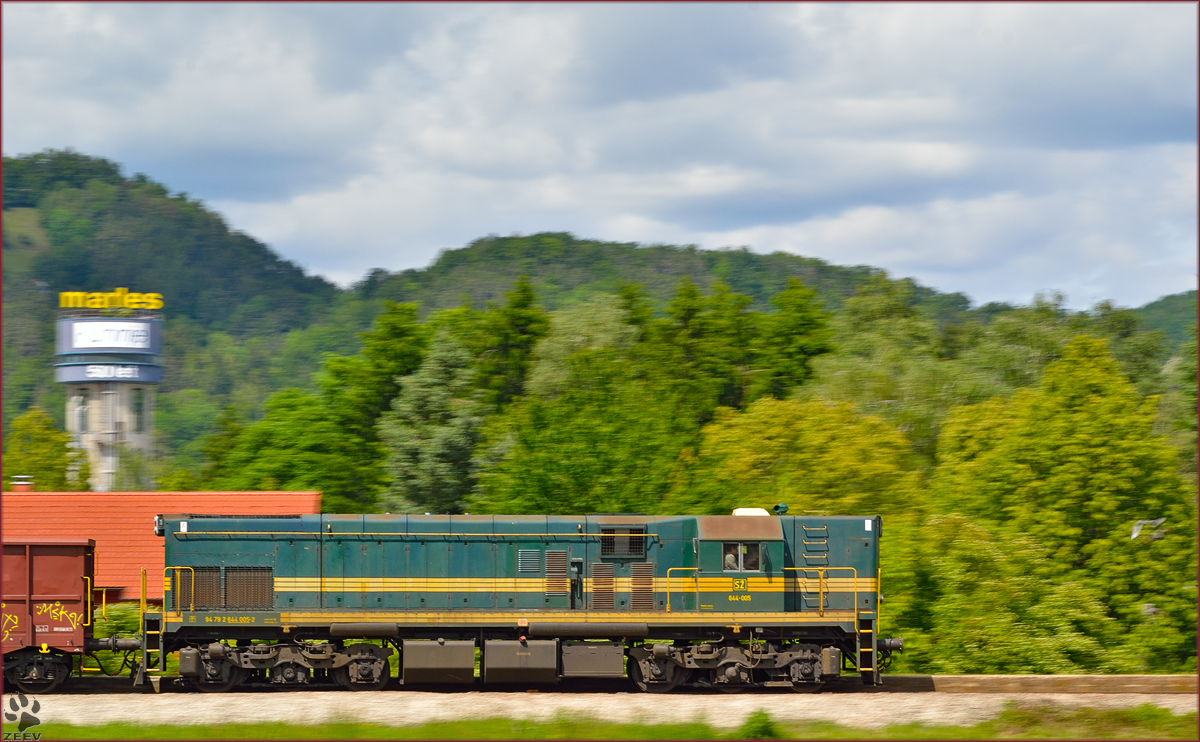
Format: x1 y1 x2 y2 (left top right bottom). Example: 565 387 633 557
379 330 484 513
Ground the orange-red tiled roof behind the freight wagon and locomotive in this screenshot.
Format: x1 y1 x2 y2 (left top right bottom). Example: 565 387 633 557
0 492 320 602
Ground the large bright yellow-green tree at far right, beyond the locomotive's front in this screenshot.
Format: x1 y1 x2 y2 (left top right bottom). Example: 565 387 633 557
935 335 1196 669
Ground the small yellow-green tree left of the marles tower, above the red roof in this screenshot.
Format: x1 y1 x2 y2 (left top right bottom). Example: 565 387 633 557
4 407 91 492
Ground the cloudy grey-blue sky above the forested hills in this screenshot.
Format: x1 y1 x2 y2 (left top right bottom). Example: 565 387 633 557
0 2 1198 309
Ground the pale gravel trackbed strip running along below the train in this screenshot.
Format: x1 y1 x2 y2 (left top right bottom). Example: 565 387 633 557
11 676 1196 730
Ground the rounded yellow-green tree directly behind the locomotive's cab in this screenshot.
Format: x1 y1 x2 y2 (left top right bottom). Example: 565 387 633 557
664 397 917 515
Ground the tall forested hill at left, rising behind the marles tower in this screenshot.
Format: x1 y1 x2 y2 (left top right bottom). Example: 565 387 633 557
4 151 355 431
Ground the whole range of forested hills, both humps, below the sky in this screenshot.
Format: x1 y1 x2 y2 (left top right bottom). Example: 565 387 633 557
4 146 993 429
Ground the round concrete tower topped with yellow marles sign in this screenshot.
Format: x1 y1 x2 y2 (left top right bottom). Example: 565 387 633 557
54 288 162 492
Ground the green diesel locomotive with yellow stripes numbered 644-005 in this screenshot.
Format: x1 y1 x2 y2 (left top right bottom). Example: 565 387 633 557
137 505 901 692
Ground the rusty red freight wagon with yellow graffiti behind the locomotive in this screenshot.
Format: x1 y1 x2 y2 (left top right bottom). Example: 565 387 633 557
0 539 140 693
